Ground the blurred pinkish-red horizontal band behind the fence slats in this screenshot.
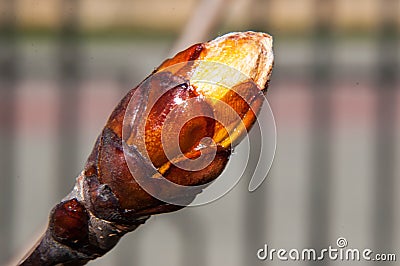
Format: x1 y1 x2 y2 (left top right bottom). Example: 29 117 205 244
0 80 400 134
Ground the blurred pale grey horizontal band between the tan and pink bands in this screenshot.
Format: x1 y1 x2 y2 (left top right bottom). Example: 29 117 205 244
10 38 400 81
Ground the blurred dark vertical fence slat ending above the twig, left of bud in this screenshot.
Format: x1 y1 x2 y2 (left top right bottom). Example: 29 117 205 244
57 0 82 197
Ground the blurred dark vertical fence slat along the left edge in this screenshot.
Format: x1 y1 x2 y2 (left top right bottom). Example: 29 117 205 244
0 0 18 263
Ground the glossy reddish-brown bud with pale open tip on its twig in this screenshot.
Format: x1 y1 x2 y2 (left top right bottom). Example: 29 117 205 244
18 32 273 266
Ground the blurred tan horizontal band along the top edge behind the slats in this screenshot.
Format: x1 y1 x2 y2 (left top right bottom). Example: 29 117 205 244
3 0 400 31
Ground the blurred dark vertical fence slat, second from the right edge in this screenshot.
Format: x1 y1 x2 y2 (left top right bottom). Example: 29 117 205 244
307 0 334 265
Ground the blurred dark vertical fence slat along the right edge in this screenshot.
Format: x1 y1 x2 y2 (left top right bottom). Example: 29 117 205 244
371 0 400 260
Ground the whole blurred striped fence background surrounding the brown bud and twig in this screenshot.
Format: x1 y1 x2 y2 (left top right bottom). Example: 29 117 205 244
0 0 400 266
